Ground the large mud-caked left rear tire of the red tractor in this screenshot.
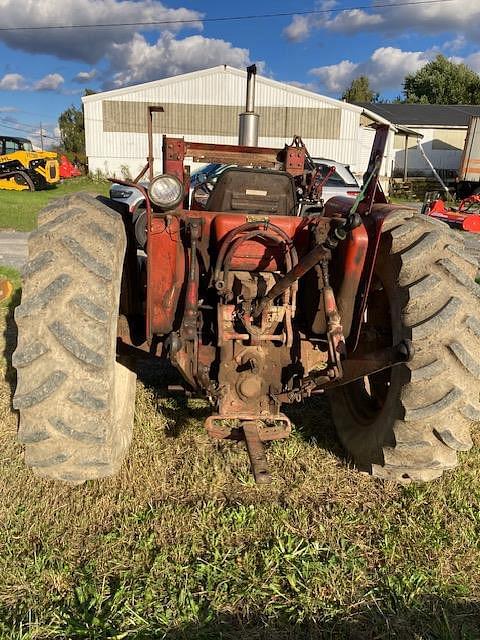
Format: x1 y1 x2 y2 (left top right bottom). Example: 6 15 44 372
13 193 135 484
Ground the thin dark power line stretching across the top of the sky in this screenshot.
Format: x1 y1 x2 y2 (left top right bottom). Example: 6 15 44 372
0 0 455 31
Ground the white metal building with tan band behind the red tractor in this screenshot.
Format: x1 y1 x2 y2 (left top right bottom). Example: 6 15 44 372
82 65 394 177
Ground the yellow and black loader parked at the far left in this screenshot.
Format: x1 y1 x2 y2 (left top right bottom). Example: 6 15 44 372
0 136 60 191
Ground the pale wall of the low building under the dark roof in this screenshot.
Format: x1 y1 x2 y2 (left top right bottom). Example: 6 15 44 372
394 127 467 175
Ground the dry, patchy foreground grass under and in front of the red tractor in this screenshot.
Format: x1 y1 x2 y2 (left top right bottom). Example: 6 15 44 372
0 274 480 640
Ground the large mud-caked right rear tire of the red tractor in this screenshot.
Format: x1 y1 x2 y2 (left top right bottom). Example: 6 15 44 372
329 211 480 482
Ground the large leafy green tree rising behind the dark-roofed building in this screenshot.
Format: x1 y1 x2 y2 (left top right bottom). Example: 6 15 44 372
403 55 480 104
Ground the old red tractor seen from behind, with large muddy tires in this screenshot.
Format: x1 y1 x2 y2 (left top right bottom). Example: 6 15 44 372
13 69 480 483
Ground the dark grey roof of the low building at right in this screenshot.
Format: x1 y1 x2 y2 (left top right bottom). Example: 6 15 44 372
354 102 480 127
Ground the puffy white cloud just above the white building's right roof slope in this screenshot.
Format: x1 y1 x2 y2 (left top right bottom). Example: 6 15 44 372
310 47 432 93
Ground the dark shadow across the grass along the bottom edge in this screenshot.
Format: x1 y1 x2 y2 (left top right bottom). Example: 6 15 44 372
4 596 480 640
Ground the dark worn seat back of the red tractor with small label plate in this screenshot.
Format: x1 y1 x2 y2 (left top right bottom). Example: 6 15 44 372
206 167 297 216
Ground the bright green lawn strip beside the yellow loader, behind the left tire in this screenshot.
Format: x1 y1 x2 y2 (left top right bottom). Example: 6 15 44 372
0 177 110 231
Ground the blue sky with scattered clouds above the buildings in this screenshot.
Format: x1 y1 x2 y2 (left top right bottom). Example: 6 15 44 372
0 0 480 144
